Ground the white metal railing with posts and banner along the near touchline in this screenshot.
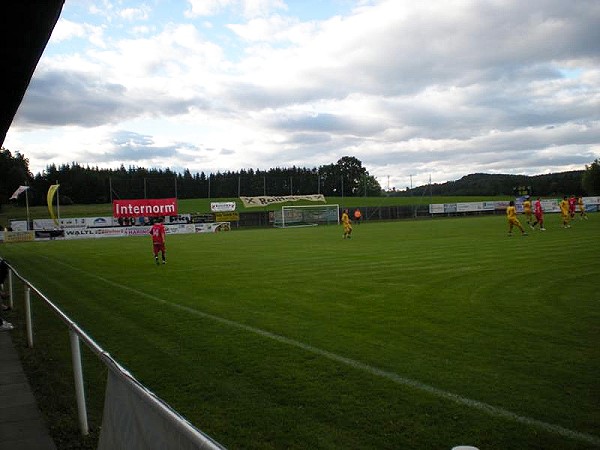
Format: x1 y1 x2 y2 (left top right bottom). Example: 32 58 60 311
2 264 225 450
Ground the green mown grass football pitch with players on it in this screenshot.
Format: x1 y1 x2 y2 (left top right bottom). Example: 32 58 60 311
0 214 600 449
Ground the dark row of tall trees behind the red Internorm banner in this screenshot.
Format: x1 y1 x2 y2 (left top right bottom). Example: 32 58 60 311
0 149 382 205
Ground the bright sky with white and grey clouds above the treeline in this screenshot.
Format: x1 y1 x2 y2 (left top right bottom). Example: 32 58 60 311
4 0 600 189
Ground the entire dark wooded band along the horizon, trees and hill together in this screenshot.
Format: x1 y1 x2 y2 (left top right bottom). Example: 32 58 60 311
0 148 600 207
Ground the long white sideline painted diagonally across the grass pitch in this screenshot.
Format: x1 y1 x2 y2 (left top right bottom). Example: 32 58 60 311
38 258 600 447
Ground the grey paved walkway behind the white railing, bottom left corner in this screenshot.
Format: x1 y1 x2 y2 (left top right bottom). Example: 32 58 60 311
0 331 56 450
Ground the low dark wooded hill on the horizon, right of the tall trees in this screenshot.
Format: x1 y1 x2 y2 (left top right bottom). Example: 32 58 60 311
392 170 585 197
